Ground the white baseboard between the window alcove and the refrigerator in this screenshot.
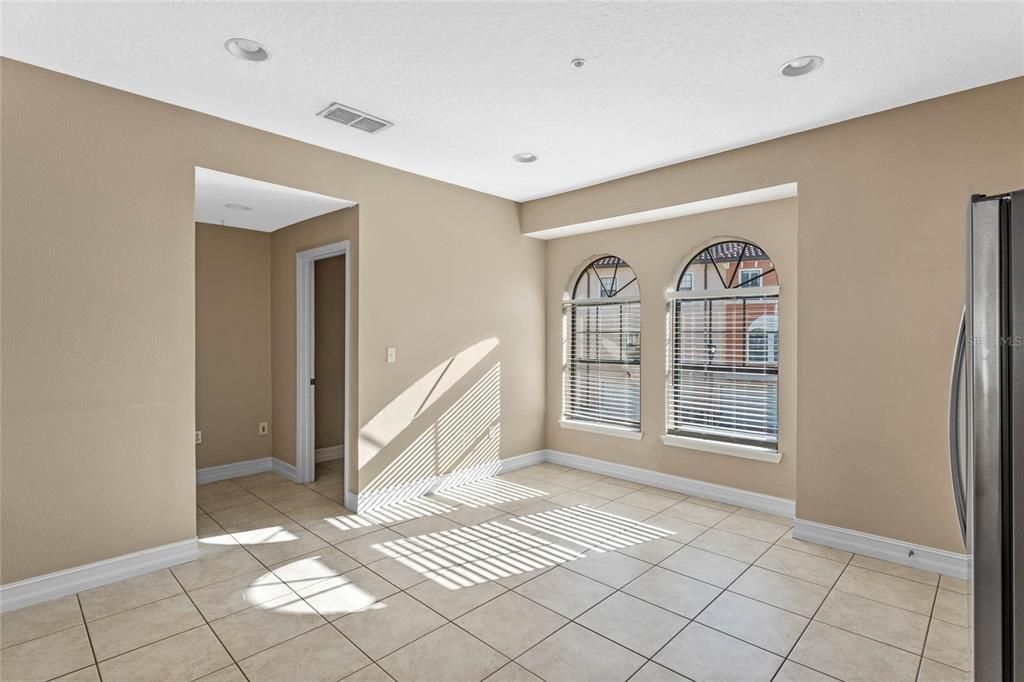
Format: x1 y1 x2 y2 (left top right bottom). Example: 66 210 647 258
793 518 971 581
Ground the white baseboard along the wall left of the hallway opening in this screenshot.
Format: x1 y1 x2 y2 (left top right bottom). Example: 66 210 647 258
0 538 199 612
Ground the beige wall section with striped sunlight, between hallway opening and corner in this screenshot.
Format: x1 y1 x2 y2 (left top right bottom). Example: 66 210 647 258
350 184 545 491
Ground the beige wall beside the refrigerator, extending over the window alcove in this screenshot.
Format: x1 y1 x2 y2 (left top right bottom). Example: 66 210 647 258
520 79 1024 551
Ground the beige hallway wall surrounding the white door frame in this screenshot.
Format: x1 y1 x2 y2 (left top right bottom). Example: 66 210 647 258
270 207 360 483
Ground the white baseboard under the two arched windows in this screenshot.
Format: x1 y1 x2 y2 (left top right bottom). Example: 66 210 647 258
544 450 796 518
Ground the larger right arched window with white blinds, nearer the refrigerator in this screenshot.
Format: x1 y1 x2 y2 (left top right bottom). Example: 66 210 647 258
668 242 779 452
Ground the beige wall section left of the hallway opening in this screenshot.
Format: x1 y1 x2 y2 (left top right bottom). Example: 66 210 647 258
0 66 196 583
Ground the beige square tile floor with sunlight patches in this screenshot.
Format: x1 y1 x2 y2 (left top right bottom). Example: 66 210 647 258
0 464 971 682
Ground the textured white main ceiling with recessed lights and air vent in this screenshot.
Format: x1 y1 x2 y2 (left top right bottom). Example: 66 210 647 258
0 0 1024 201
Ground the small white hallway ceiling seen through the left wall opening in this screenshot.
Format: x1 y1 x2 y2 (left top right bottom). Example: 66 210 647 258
196 168 353 232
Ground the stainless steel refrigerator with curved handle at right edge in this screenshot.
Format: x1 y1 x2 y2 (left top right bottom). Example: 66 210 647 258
949 190 1024 682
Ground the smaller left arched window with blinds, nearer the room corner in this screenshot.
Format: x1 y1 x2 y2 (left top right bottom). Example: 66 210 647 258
562 256 640 432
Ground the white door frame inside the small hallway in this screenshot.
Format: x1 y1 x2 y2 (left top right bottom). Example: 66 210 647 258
295 240 352 500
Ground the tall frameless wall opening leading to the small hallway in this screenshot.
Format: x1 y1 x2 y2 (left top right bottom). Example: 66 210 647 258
196 168 358 504
